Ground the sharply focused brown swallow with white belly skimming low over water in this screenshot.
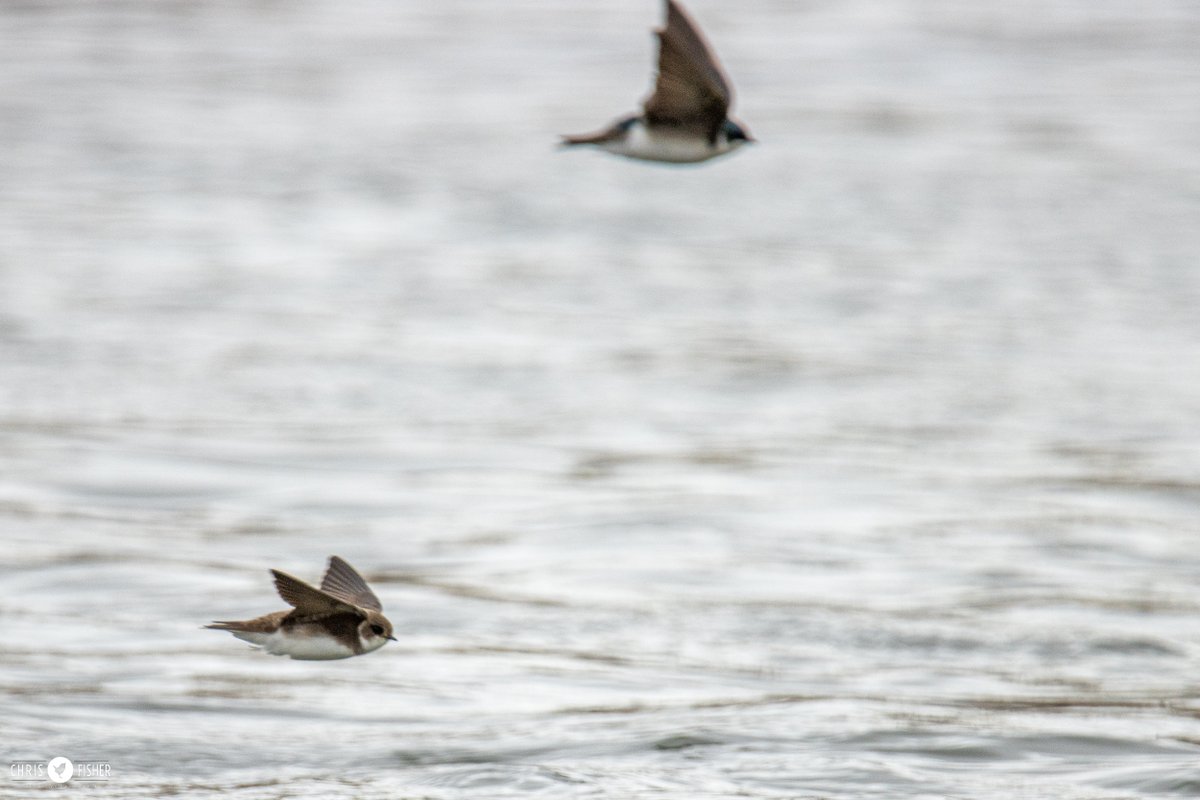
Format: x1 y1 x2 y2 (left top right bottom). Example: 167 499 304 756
205 555 396 661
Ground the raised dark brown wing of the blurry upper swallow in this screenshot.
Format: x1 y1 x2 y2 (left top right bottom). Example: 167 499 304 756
643 0 733 139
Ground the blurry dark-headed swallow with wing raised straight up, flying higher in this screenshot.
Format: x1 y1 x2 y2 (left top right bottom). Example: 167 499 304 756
563 0 754 163
